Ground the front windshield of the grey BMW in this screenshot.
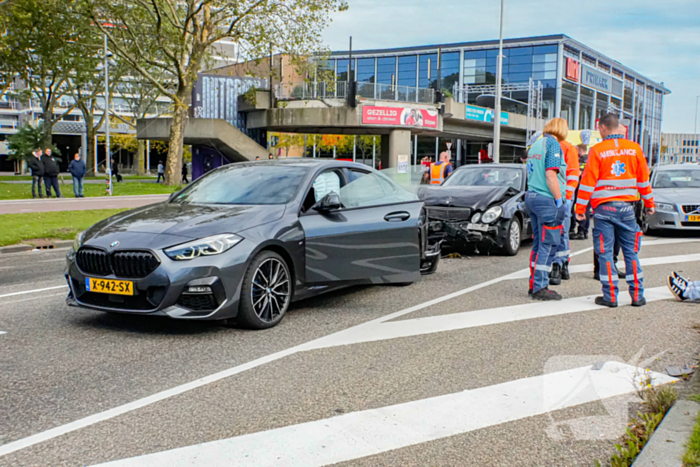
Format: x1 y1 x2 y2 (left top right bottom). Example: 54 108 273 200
173 164 307 204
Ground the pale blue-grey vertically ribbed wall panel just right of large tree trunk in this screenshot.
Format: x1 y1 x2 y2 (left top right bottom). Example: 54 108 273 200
192 73 267 129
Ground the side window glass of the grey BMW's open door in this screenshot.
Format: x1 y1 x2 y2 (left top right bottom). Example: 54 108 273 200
338 171 416 208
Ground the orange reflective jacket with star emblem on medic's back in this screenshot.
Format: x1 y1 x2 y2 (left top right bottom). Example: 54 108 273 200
576 138 654 214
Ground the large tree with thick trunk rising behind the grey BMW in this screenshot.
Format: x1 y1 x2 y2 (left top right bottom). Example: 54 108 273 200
79 0 347 185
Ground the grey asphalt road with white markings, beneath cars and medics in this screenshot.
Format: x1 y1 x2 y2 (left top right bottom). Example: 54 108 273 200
0 236 700 467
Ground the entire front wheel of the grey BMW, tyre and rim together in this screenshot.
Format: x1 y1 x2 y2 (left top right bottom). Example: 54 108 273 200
234 250 293 329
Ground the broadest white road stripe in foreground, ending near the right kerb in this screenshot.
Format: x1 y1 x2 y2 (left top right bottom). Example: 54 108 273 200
91 362 676 467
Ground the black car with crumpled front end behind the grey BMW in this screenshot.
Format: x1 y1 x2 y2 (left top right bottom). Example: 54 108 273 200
418 164 532 256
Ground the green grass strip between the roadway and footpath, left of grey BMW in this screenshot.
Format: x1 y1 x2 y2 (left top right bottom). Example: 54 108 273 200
0 209 126 246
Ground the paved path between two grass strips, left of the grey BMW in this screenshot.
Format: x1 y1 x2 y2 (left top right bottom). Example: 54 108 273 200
0 194 170 214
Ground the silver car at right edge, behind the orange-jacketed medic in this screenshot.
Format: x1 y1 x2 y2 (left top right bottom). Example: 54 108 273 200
637 164 700 234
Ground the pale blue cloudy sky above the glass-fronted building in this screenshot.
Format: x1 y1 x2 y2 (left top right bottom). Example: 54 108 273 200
324 0 700 133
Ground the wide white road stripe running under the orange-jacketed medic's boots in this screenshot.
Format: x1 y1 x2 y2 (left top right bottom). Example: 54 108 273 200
304 287 673 350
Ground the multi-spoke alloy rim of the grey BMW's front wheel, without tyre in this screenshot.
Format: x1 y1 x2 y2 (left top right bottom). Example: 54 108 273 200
250 258 291 323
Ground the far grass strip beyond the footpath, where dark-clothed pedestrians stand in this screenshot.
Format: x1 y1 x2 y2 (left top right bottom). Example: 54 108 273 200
0 180 180 200
